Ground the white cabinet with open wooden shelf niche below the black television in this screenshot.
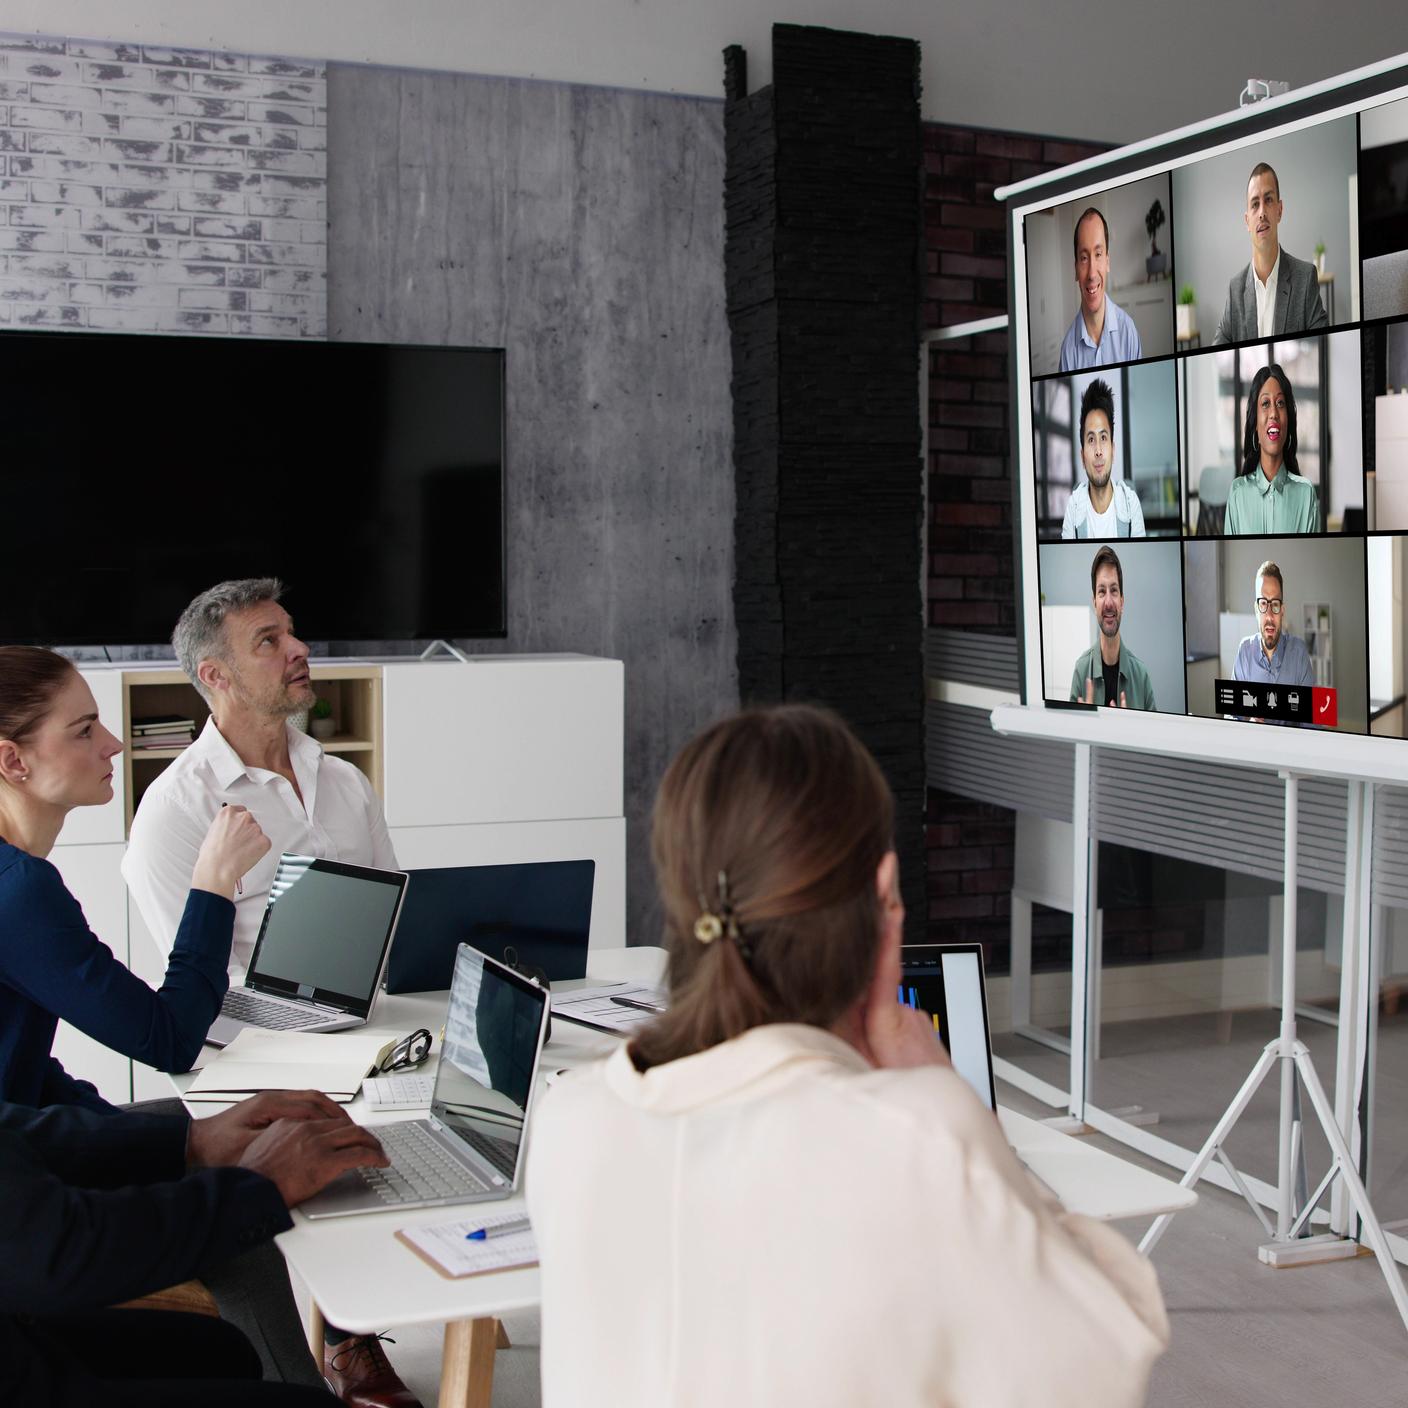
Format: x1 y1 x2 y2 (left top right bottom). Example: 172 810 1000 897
51 655 625 1102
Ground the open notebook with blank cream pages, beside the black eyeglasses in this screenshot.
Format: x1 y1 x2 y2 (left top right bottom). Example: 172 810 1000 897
184 1026 386 1102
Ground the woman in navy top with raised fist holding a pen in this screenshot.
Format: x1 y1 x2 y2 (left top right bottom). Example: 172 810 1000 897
0 645 269 1110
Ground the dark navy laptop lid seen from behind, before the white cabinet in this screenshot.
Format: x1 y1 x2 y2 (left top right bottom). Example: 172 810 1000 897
386 860 597 993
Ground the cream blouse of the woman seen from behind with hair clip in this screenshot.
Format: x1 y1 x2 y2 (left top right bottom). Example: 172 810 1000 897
527 1025 1169 1408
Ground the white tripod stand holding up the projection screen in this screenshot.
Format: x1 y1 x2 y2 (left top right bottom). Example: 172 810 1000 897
1139 773 1408 1329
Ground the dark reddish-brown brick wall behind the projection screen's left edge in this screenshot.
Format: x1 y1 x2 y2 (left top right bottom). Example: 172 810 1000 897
924 124 1102 972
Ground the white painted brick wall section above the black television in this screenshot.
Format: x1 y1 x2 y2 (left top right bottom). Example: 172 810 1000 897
0 34 328 338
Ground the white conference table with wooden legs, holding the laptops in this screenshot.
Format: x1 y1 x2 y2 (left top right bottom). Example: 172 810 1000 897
184 948 1197 1408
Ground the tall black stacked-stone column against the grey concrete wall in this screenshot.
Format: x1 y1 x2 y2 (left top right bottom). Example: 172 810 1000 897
724 25 925 936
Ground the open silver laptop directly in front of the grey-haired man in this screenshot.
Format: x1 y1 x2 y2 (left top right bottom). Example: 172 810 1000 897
206 853 406 1046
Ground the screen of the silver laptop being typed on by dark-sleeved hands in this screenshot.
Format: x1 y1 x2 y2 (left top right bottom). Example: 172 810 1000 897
431 943 548 1177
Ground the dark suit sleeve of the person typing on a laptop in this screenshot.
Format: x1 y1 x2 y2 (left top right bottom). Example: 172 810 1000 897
0 1111 290 1315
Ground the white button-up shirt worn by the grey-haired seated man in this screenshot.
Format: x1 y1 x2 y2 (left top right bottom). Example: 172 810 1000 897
122 719 396 983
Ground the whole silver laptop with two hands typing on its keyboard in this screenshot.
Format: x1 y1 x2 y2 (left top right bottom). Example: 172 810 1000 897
298 943 548 1218
